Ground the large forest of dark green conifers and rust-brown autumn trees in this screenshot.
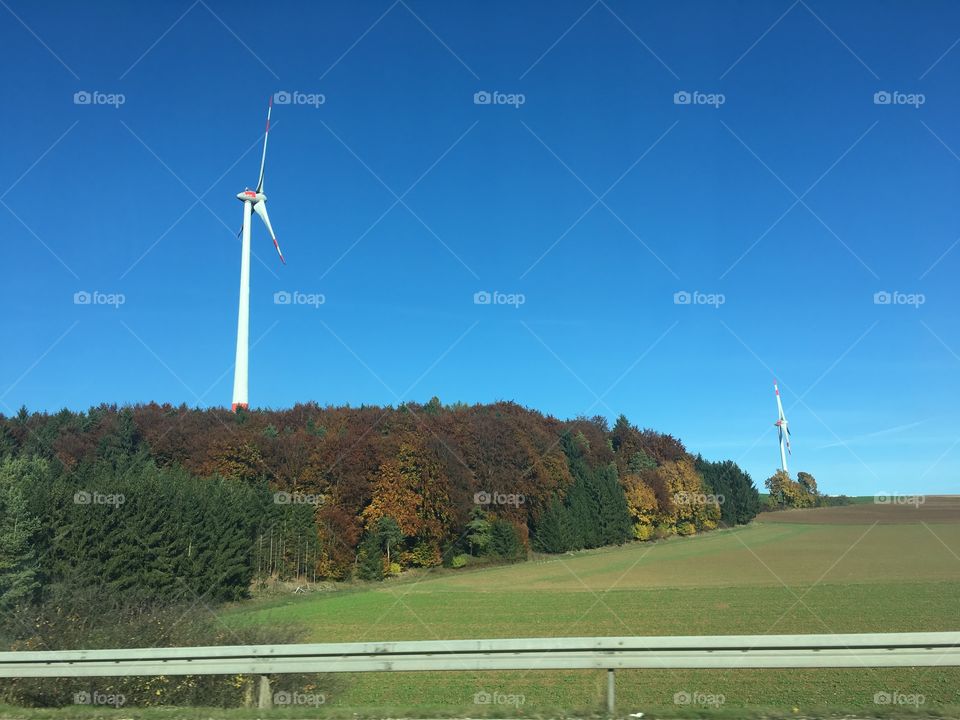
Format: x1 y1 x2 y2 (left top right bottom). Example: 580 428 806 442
0 398 759 609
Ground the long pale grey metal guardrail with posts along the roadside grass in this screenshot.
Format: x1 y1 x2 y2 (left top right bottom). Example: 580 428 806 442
0 632 960 712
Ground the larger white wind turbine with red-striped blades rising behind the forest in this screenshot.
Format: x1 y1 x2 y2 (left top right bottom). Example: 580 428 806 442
230 96 287 412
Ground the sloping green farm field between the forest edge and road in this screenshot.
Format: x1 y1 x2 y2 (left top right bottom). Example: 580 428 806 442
216 500 960 716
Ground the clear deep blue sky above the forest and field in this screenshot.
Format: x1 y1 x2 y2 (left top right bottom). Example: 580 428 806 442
0 0 960 494
